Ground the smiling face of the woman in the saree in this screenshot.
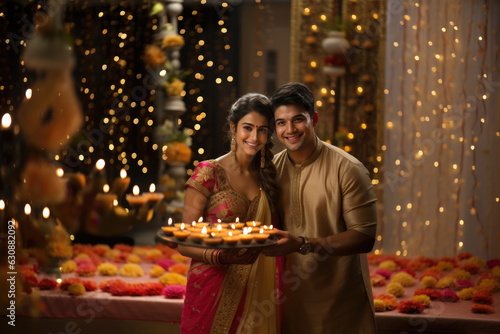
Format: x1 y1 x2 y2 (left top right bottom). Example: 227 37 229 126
231 111 269 156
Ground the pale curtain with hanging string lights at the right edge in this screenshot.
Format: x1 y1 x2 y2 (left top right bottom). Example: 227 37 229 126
379 0 500 259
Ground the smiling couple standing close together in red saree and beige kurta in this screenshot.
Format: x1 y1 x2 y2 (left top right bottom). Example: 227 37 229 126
179 83 376 334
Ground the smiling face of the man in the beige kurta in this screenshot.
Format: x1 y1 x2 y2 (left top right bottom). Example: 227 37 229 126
274 105 318 157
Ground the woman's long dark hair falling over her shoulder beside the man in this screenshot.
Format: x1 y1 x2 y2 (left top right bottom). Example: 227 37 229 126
227 93 279 209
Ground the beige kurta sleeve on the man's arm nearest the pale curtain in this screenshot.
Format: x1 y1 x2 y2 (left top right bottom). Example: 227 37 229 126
341 163 377 238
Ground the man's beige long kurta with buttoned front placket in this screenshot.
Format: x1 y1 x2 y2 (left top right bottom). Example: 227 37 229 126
274 139 377 334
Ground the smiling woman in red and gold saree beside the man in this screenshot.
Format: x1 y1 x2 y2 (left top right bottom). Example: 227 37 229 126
179 93 281 334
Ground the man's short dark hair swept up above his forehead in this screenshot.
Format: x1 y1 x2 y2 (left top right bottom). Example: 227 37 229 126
271 82 314 117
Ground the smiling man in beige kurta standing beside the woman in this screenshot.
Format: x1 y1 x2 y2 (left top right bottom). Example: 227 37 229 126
264 84 376 334
